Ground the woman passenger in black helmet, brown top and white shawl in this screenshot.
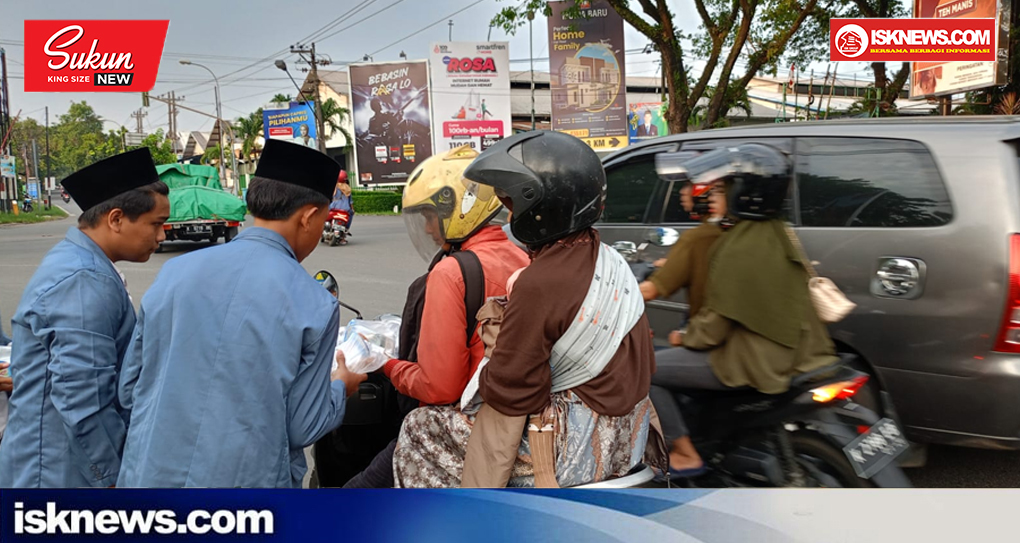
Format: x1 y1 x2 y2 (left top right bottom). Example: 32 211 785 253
394 131 655 487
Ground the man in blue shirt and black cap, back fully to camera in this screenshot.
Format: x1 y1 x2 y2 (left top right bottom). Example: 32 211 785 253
117 140 365 488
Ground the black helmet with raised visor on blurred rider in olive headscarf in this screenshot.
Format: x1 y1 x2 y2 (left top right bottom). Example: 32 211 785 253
678 143 793 220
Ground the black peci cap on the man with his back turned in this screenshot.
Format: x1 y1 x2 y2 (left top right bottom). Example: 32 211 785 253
255 139 340 200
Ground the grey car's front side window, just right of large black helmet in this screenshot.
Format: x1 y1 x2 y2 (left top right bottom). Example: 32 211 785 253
602 154 662 224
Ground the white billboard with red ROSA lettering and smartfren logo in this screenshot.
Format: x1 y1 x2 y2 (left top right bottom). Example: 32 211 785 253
429 42 513 152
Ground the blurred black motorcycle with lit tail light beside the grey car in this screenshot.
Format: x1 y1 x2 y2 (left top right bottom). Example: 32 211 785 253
614 229 911 488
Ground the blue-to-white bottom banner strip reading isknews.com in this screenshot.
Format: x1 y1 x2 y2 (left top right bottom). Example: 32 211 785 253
0 489 1020 543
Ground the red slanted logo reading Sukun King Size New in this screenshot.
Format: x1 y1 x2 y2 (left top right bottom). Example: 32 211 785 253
24 20 170 92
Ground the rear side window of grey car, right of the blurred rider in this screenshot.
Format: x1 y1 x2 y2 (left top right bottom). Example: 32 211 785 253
797 138 953 228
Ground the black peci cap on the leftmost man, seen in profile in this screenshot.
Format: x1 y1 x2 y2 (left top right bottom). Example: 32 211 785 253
60 147 159 212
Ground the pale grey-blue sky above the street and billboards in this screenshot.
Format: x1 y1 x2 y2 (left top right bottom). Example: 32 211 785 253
0 0 870 133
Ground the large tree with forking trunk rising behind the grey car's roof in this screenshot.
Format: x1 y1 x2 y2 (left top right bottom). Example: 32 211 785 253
493 0 835 133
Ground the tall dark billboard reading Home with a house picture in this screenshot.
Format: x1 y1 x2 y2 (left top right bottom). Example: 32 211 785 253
549 0 629 151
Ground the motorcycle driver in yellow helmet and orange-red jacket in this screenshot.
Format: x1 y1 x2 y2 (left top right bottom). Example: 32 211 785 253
346 146 528 488
